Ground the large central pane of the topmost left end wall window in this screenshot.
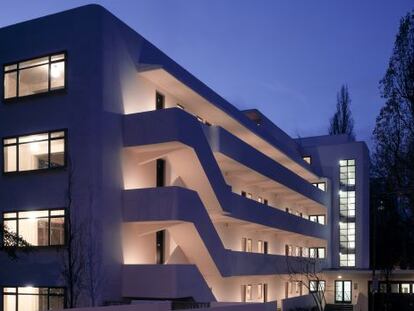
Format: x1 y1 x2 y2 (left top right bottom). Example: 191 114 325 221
19 64 49 96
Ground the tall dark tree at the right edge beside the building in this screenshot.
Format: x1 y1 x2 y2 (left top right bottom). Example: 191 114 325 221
372 12 414 275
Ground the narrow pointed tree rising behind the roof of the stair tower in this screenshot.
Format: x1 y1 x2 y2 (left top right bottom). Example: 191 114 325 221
329 85 355 138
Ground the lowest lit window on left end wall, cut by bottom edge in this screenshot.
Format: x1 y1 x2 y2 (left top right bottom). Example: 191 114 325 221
3 287 64 311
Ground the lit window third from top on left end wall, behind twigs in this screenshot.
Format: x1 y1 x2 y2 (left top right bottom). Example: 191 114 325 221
3 209 65 247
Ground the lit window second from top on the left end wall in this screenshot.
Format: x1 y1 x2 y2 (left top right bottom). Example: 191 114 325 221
3 131 66 173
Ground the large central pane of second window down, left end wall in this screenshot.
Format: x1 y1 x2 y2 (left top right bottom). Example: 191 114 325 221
19 141 49 171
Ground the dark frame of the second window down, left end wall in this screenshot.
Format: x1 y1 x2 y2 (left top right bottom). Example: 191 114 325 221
2 128 68 175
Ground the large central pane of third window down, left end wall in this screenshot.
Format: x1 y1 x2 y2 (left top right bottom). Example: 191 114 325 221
19 218 49 246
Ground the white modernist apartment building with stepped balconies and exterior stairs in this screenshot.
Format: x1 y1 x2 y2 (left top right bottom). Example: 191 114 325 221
0 5 370 311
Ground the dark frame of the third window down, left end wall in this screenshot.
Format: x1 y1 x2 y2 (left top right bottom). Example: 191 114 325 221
0 207 69 250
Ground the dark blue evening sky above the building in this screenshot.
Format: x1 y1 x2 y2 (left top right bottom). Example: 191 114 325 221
0 0 414 146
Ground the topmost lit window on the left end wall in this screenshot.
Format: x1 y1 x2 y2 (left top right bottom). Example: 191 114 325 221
3 53 66 99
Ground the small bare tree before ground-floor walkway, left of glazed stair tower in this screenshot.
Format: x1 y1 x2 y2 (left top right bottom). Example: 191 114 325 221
286 256 326 311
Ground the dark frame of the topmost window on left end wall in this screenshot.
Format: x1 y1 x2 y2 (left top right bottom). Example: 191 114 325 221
1 50 68 104
